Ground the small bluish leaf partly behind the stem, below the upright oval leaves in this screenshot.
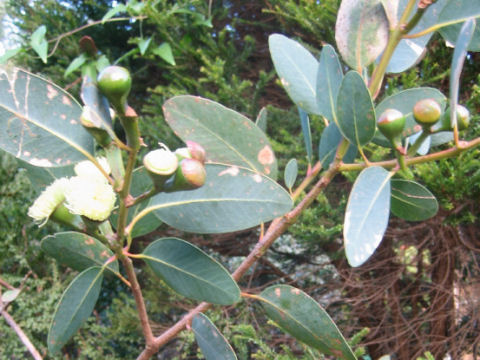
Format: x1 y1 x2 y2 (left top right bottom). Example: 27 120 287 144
318 122 357 169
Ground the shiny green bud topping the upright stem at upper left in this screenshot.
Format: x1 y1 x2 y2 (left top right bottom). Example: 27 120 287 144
97 66 132 114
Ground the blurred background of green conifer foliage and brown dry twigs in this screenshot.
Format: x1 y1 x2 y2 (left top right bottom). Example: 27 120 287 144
0 0 480 359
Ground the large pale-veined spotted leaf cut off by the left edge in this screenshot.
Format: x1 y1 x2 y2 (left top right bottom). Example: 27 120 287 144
0 69 93 167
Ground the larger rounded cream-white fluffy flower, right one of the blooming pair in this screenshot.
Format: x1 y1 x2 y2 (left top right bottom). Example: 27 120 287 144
65 176 116 221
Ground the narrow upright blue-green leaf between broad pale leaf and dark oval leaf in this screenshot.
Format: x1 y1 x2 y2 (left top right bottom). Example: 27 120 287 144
316 45 343 122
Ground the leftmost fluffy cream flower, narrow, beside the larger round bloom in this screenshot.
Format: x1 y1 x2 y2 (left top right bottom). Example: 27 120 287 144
28 178 69 223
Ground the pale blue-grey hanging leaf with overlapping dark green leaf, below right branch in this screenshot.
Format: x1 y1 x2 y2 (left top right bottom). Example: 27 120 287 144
343 166 438 266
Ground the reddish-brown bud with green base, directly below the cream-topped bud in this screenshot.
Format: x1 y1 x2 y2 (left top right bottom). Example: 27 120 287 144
164 159 207 192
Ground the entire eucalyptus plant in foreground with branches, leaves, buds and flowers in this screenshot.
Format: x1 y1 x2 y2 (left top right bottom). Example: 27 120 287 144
0 0 480 359
